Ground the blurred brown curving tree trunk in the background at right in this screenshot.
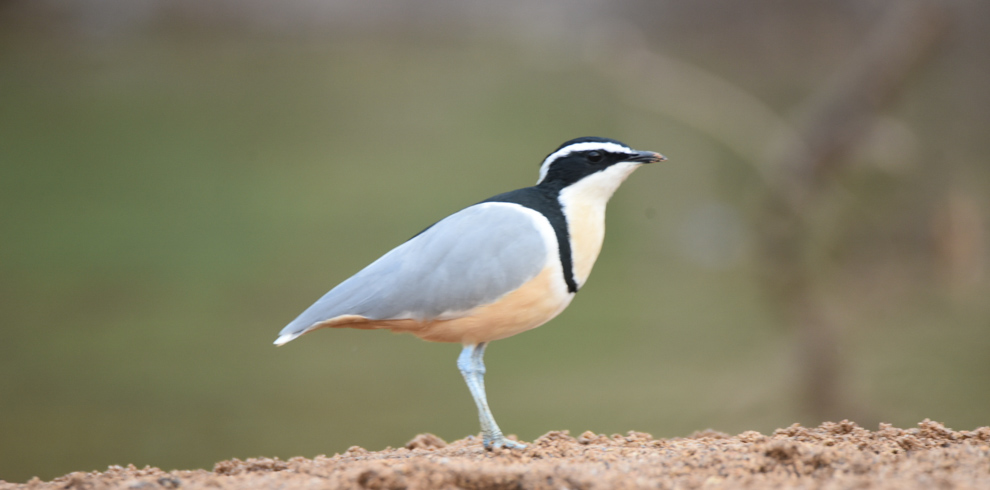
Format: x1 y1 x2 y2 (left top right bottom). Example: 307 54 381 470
759 1 945 420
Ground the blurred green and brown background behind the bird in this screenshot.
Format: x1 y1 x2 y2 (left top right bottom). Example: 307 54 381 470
0 0 990 481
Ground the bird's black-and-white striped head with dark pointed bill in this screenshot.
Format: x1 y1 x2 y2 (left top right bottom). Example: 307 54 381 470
537 136 666 191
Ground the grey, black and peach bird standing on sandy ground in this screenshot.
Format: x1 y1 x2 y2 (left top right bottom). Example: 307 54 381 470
275 136 666 449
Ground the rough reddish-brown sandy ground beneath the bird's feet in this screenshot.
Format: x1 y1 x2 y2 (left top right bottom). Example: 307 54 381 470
0 420 990 490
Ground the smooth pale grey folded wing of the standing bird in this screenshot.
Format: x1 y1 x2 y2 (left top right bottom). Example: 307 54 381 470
275 203 552 344
